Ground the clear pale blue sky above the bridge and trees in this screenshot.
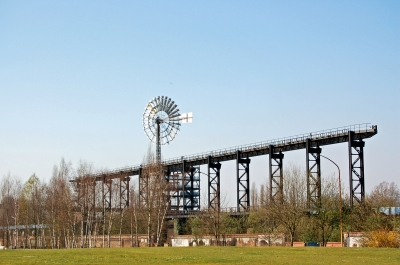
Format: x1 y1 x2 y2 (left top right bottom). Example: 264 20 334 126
0 1 400 204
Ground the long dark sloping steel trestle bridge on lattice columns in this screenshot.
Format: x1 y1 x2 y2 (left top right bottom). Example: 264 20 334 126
71 123 378 216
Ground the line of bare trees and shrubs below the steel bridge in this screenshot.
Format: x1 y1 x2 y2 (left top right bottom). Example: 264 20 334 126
0 154 400 248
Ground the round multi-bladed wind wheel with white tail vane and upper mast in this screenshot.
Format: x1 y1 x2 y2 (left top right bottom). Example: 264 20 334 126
143 96 193 162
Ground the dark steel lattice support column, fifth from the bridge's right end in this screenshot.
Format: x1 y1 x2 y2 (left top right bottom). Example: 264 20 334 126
208 156 221 211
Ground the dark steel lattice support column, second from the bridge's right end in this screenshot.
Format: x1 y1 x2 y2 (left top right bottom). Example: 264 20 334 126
306 139 322 210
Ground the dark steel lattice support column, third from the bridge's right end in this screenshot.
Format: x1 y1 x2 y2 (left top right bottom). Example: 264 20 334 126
269 145 284 203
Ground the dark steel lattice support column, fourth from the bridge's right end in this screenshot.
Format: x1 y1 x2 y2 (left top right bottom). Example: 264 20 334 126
236 151 250 212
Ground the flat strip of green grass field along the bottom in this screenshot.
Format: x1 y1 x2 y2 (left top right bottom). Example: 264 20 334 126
0 247 400 265
